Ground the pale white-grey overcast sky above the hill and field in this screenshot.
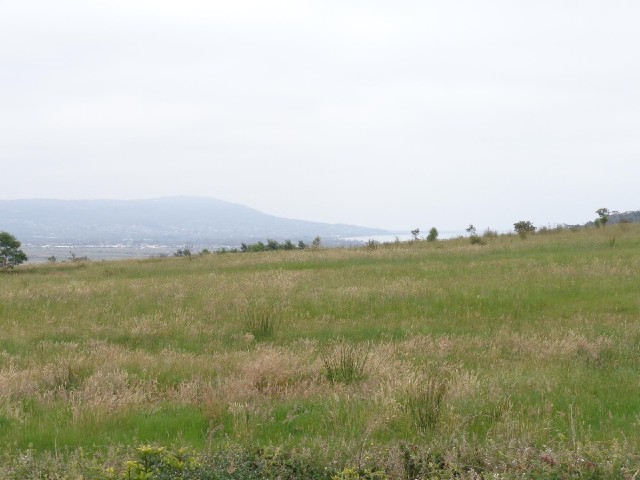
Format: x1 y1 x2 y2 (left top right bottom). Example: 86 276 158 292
0 0 640 232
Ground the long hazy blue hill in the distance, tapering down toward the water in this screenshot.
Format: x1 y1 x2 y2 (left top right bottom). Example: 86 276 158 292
0 197 389 244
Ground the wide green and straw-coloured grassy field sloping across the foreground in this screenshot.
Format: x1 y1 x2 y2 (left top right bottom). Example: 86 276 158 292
0 225 640 479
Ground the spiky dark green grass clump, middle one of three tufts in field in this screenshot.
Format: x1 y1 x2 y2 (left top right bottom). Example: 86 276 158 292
323 340 371 384
